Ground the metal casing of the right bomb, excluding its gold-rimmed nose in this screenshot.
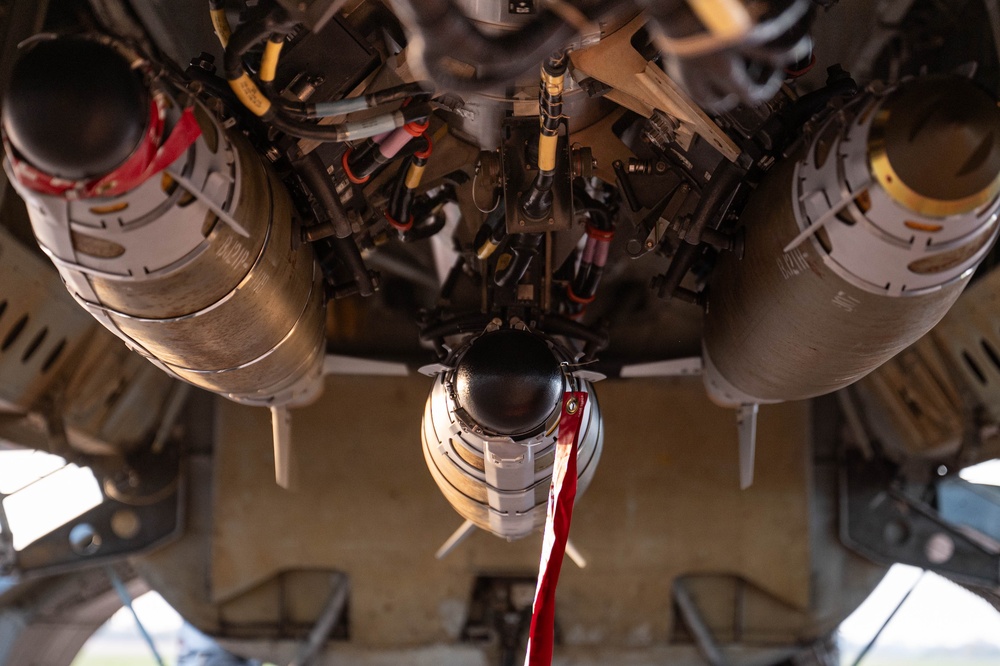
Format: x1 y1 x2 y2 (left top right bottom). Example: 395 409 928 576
703 77 1000 405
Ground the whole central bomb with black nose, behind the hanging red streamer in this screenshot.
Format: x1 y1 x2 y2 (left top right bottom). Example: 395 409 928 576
421 327 604 540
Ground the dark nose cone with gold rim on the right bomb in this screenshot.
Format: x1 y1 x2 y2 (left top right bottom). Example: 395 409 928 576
869 77 1000 217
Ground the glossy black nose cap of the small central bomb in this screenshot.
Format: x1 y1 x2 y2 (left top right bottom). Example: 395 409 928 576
455 329 563 435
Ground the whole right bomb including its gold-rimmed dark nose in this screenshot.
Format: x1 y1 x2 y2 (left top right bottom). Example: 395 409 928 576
703 77 1000 405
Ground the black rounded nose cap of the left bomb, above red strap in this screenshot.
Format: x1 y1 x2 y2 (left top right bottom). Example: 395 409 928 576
3 38 149 180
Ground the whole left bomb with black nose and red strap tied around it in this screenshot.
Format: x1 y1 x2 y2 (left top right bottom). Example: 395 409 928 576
3 36 324 406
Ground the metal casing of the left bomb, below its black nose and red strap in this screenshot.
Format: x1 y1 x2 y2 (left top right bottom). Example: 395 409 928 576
8 94 325 405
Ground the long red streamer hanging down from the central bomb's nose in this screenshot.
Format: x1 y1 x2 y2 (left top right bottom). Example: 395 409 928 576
524 391 587 666
